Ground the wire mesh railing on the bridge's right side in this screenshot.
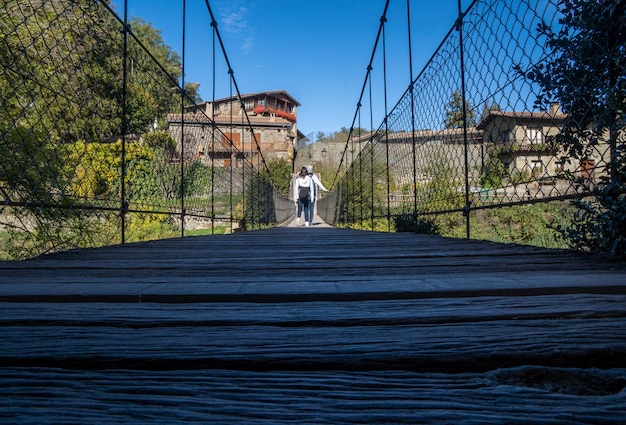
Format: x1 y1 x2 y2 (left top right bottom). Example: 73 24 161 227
318 0 624 248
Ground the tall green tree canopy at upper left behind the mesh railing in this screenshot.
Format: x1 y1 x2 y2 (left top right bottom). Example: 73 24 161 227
0 0 180 176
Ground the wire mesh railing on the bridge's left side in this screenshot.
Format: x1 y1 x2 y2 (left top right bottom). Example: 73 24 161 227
0 0 287 259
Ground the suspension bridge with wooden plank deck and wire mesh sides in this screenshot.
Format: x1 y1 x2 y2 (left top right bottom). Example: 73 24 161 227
0 0 626 424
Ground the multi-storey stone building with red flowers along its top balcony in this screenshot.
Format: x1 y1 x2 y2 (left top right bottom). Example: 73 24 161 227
167 90 300 167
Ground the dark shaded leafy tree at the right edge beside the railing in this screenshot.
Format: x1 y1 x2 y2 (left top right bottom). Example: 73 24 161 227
518 0 626 255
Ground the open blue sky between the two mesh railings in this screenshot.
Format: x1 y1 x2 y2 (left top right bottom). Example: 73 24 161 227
118 0 471 135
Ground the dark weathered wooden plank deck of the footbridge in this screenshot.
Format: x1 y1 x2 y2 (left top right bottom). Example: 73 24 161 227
0 226 626 424
